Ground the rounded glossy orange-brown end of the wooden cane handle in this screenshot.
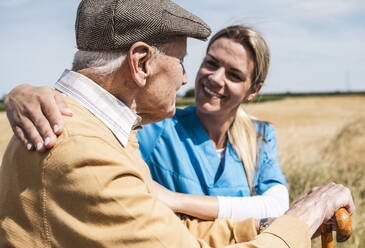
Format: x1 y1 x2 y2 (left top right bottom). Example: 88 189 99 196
335 208 352 242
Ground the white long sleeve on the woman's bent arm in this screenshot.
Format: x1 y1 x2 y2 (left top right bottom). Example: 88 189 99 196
218 184 289 220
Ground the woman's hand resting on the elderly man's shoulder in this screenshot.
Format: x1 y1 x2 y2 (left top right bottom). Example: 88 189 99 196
4 84 72 151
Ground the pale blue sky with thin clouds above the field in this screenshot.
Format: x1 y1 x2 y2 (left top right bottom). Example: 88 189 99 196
0 0 365 97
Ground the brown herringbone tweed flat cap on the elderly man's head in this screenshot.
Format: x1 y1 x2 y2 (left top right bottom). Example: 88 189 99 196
75 0 211 51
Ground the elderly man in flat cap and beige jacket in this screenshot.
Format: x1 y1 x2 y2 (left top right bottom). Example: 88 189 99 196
0 0 354 247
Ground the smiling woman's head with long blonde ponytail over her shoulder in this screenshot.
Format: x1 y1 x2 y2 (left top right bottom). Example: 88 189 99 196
195 26 270 194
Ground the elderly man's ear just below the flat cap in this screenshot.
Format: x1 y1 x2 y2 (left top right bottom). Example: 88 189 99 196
128 41 152 87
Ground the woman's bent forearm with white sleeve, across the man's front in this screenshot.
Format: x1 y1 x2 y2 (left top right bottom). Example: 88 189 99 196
154 182 289 220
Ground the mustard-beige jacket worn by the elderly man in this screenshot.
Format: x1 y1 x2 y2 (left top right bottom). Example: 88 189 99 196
0 98 310 248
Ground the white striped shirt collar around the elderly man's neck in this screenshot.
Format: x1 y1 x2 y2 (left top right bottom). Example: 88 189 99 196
55 70 141 147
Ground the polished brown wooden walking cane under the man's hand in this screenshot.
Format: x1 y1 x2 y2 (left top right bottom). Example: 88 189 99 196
321 208 352 248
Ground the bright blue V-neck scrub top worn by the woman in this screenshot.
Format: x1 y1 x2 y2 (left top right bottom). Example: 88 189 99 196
137 106 287 196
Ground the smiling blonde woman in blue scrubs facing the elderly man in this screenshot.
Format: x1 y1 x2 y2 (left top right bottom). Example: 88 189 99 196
138 26 288 219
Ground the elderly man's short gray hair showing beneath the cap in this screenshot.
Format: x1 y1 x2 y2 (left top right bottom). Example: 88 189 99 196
72 47 163 75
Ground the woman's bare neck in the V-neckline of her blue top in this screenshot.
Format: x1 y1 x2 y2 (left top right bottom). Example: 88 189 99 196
195 109 235 149
